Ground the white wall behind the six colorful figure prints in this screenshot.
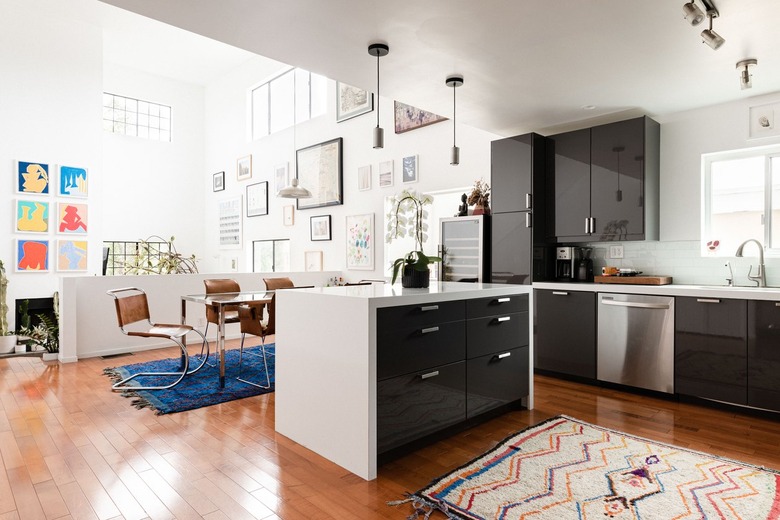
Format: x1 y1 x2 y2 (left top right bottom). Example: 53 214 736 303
0 0 103 327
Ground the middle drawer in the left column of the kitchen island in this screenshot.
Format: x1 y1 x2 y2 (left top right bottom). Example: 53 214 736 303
377 320 466 379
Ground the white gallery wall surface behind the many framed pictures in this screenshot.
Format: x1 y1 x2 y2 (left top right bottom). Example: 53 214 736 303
202 58 498 279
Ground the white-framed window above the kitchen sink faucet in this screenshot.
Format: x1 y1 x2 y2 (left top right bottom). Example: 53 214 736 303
702 146 780 256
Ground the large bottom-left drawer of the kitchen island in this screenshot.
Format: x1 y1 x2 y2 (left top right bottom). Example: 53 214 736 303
376 361 466 453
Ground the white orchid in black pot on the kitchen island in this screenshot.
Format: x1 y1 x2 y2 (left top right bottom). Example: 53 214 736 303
385 190 441 288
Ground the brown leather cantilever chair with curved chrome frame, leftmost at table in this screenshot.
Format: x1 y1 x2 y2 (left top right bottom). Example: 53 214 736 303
107 287 209 390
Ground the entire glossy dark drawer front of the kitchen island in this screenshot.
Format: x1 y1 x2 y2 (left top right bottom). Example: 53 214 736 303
377 295 529 453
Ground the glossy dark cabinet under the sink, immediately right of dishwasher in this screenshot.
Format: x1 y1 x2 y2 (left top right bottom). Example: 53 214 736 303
674 297 748 405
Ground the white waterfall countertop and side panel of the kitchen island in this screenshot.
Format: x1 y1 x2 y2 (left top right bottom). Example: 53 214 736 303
275 281 533 480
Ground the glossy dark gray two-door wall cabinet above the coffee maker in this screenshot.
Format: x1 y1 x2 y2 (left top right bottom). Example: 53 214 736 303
547 117 660 242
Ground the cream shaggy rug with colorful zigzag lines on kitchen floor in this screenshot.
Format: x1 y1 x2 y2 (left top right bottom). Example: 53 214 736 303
404 416 780 520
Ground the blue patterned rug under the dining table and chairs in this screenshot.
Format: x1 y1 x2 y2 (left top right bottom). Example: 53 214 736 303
103 343 276 415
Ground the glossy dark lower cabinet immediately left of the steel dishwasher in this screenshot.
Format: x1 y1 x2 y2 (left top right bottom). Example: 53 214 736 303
534 289 596 379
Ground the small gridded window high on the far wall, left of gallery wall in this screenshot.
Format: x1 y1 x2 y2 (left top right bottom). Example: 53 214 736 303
103 92 171 141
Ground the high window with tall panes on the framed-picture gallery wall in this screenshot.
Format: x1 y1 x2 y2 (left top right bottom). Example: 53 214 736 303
250 69 327 140
